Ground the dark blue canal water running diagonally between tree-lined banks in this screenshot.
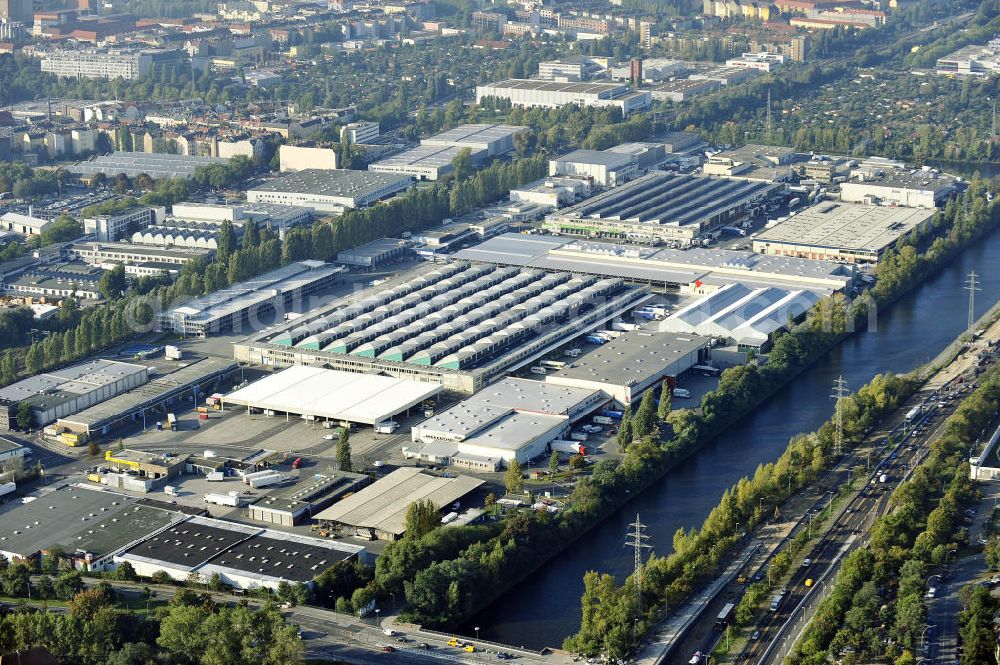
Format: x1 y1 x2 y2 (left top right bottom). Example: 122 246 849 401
465 197 1000 648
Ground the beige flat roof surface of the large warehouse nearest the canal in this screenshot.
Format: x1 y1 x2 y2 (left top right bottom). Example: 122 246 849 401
754 201 937 252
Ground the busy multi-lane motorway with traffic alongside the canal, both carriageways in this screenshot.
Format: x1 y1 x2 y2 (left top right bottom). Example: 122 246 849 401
639 312 1000 663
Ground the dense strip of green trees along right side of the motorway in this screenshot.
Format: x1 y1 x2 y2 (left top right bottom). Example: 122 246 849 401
790 369 1000 664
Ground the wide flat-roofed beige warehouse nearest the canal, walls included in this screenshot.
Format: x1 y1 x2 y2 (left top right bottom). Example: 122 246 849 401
753 201 936 263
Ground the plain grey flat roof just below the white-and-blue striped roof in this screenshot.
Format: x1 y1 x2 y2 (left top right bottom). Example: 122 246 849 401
546 328 711 385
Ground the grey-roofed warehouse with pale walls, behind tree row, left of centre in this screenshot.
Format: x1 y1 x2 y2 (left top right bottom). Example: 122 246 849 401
247 169 413 213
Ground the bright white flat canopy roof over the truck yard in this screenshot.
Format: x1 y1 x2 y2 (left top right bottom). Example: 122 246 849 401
224 365 441 425
